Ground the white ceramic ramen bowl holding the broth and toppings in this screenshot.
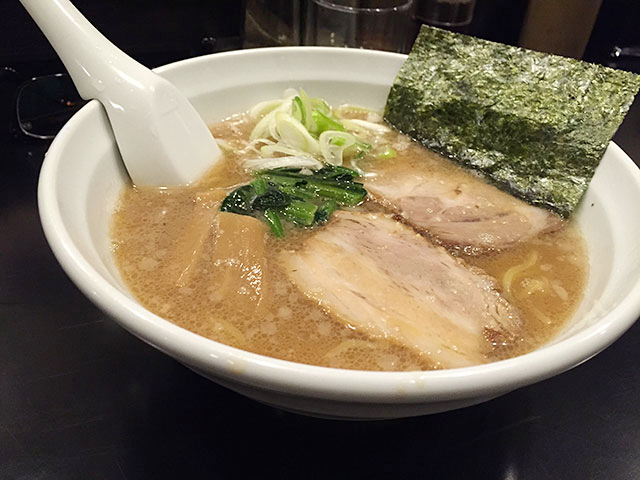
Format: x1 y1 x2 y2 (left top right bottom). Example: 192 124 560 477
38 47 640 419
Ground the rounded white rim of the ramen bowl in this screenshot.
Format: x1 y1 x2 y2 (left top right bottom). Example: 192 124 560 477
38 47 640 403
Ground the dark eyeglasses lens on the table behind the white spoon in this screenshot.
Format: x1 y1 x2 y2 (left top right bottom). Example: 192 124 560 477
12 73 87 140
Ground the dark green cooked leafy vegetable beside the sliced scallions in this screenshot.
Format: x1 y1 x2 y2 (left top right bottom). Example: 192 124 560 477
220 166 367 237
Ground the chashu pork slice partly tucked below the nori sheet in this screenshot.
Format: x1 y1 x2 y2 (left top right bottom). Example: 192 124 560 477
365 159 562 254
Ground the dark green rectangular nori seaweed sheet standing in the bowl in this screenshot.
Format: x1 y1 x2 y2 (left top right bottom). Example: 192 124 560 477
384 26 640 217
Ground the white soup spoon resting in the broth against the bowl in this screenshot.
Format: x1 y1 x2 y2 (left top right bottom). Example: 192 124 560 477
20 0 221 186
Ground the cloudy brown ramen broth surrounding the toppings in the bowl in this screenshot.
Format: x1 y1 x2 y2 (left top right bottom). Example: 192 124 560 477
111 109 588 370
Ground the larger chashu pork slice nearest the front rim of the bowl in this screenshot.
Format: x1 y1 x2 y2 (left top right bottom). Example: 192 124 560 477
280 211 519 368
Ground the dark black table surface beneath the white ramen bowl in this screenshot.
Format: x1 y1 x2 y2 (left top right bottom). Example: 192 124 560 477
0 80 640 480
